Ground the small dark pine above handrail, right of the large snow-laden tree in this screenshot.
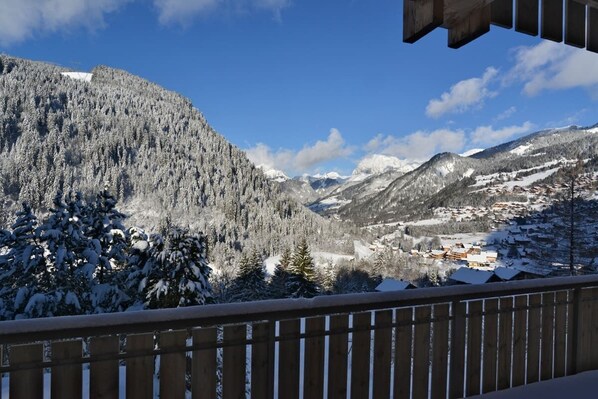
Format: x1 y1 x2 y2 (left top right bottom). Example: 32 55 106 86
233 249 268 302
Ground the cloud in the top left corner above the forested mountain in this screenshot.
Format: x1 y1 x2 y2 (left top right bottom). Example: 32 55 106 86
0 0 130 46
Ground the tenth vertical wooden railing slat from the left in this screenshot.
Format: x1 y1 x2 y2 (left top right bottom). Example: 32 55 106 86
303 317 326 399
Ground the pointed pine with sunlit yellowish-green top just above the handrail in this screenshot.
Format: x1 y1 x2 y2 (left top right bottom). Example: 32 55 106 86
287 238 318 298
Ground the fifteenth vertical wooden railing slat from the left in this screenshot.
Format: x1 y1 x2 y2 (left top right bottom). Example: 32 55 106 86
413 306 432 398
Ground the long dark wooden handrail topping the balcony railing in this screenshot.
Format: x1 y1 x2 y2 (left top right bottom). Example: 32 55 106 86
0 275 598 344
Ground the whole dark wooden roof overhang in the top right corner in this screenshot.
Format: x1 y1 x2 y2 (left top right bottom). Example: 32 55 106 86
403 0 598 52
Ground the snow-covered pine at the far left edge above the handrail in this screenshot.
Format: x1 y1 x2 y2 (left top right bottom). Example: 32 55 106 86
0 203 50 319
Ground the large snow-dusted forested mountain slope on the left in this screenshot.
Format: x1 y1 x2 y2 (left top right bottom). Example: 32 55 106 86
0 55 350 262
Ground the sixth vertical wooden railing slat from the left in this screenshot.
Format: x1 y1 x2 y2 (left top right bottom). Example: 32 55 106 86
191 327 218 399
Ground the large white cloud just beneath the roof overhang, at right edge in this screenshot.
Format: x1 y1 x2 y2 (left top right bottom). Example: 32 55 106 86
506 41 598 96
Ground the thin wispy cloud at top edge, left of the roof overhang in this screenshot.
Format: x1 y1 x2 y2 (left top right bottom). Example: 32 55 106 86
154 0 291 25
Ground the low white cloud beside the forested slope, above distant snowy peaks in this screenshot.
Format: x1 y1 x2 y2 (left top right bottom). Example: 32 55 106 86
245 129 354 174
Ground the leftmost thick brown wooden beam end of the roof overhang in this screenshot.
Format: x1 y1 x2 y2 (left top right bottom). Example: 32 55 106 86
403 0 444 43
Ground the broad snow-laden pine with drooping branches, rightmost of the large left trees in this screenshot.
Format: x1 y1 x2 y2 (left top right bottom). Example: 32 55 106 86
144 227 212 308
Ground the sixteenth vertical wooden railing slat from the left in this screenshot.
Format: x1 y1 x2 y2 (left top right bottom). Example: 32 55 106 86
431 304 449 399
